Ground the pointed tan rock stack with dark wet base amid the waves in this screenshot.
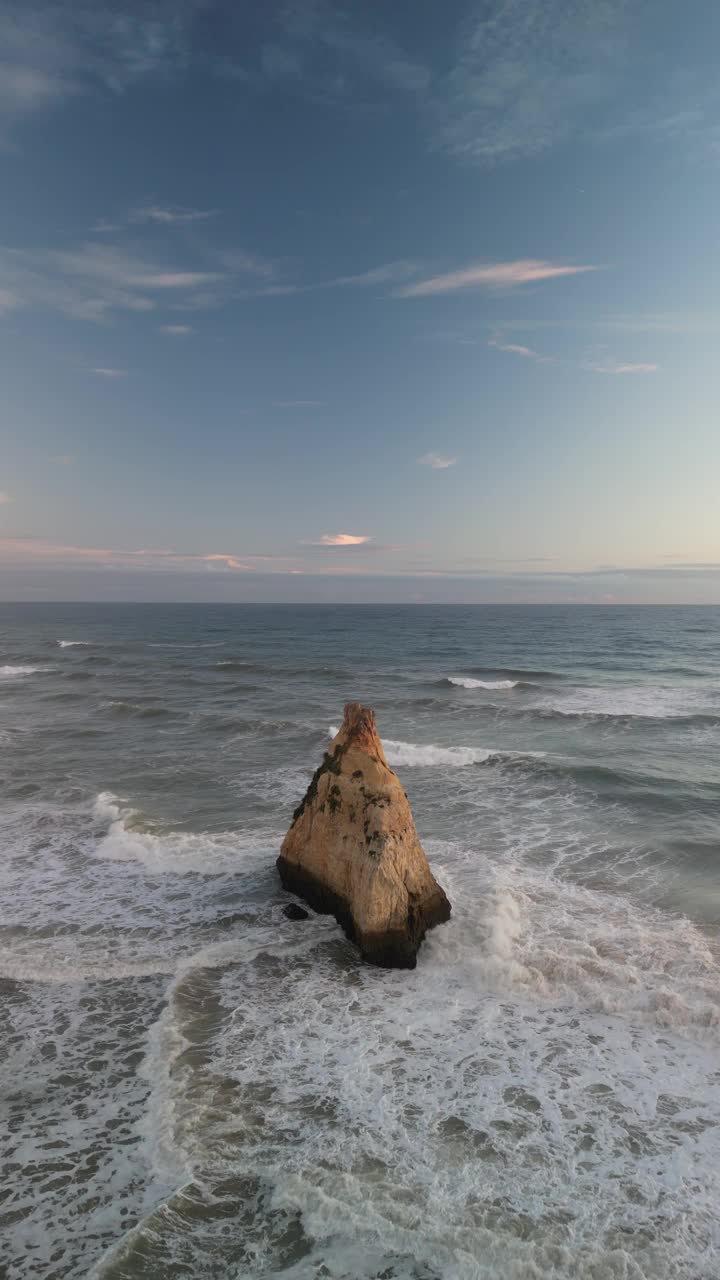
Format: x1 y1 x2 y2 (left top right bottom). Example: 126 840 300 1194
278 703 450 969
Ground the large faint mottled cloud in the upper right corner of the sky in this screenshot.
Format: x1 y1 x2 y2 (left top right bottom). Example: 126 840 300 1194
428 0 717 165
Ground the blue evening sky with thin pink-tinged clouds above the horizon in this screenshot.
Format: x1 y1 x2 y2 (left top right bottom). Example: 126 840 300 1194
0 0 720 603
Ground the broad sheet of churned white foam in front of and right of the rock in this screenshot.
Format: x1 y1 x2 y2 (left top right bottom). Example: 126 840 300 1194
130 829 720 1280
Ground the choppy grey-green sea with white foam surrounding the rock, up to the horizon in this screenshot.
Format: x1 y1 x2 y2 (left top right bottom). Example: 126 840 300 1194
0 605 720 1280
